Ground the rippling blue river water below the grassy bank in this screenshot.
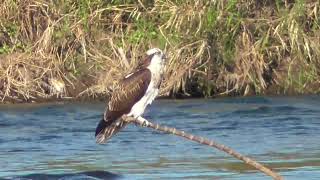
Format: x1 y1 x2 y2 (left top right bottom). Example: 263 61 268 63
0 96 320 180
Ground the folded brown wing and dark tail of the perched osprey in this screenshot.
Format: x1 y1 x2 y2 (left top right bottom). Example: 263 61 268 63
96 69 151 143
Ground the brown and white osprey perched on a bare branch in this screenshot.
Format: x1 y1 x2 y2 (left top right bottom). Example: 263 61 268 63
95 48 166 144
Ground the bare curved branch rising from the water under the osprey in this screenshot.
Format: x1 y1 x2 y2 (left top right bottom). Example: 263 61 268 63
126 117 283 180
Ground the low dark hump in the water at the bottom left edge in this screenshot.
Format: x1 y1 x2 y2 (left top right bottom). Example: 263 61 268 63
4 171 122 180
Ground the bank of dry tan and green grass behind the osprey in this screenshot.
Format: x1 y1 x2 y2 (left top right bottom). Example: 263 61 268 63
0 0 320 102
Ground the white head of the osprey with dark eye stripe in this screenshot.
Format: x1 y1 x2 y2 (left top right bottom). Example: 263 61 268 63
139 48 167 71
